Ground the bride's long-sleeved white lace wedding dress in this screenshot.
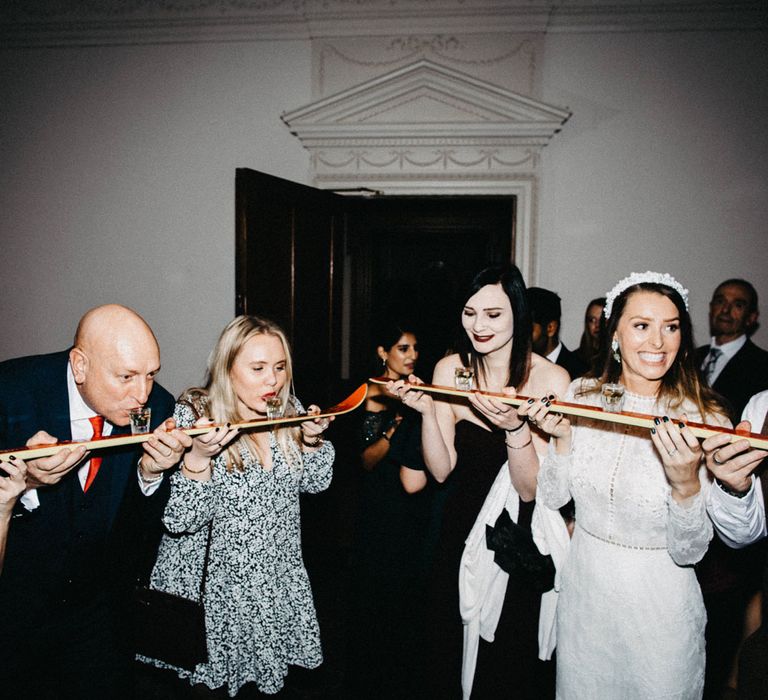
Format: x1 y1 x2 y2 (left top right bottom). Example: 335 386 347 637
537 380 712 700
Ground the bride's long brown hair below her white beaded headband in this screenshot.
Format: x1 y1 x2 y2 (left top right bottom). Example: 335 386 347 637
584 282 725 417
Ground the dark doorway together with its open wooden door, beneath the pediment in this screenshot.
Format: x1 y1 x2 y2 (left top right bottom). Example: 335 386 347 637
235 169 515 405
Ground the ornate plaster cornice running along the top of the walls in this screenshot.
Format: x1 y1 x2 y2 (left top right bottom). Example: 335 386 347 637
0 0 768 47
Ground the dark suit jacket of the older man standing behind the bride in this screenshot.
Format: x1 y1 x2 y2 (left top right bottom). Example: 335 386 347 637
696 339 768 425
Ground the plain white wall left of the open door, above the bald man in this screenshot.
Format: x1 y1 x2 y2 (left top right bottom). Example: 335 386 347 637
0 42 310 392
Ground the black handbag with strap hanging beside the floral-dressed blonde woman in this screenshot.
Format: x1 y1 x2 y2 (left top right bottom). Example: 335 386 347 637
133 523 213 671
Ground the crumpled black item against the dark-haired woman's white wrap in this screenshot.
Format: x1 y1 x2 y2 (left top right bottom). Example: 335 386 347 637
485 509 555 593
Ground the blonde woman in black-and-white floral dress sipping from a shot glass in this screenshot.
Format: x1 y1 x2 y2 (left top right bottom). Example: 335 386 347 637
142 316 334 696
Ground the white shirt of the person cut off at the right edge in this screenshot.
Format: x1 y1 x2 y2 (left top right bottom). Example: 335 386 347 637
707 388 768 549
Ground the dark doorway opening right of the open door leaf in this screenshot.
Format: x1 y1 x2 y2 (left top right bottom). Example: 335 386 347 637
348 197 515 379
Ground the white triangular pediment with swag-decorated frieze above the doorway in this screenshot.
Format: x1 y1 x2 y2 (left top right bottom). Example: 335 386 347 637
282 59 570 186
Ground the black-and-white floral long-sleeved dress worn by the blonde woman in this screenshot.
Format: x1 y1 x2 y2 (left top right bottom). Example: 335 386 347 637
139 400 334 697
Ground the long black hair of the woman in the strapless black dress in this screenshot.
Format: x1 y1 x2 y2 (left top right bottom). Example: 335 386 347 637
456 263 532 388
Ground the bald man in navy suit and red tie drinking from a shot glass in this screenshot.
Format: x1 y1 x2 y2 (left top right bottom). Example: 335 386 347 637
0 305 191 698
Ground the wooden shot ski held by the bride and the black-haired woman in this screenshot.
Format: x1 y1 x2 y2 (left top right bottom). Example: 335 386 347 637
368 377 768 450
